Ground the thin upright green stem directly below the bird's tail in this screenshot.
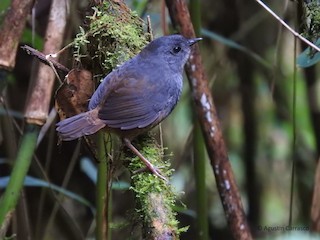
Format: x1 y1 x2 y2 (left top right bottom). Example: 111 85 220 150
96 131 108 240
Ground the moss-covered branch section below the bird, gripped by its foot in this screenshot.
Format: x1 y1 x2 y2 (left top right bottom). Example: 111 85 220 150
126 134 184 239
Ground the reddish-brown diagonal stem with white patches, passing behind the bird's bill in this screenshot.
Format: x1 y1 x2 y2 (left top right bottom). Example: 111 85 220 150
166 0 252 239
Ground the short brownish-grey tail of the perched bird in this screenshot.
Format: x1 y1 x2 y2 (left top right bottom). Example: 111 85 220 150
56 109 105 141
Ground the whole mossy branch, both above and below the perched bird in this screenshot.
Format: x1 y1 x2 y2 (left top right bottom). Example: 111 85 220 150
74 1 184 239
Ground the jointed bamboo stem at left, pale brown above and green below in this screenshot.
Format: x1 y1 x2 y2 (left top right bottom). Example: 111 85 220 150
0 0 67 236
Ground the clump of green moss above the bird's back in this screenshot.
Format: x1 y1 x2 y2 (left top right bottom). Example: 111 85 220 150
74 1 148 79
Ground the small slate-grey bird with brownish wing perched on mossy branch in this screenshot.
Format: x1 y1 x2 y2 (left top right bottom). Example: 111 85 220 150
57 35 201 179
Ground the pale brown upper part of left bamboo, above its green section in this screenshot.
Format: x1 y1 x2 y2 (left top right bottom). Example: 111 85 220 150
25 0 68 125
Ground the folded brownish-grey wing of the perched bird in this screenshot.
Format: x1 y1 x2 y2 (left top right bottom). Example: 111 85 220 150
98 75 162 130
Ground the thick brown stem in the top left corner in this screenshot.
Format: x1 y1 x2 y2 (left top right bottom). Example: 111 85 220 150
0 0 34 71
